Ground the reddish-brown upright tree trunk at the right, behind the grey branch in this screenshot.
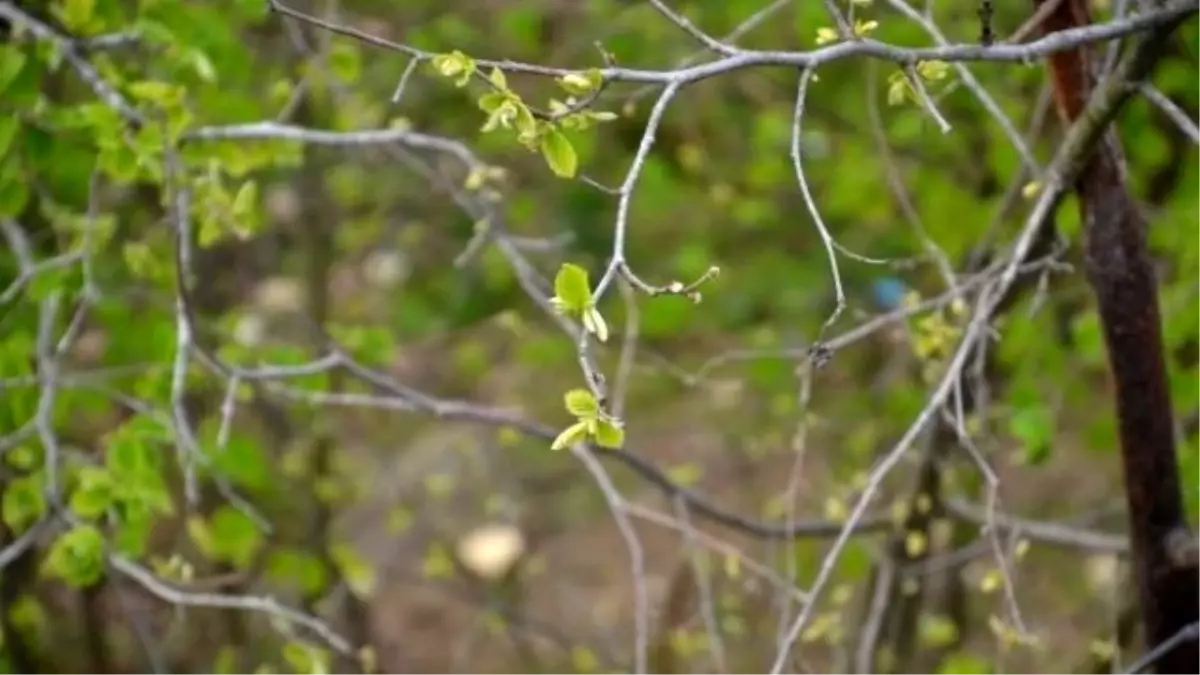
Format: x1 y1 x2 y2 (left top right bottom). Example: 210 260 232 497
1034 0 1200 662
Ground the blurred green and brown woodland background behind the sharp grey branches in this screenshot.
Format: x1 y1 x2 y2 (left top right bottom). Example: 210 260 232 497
0 0 1200 675
